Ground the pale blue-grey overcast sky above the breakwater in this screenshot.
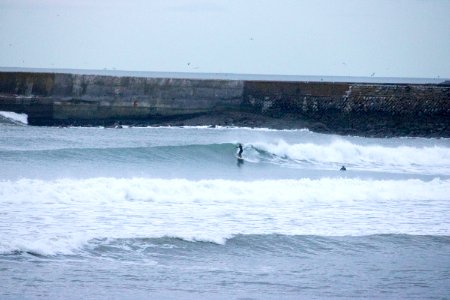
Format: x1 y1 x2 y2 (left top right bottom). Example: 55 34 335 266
0 0 450 78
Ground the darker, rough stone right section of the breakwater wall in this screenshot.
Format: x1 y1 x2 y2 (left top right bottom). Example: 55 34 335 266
243 81 450 136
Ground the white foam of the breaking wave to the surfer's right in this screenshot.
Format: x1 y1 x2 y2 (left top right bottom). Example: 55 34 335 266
254 139 450 175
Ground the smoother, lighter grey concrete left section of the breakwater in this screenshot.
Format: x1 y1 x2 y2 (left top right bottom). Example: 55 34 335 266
0 73 243 125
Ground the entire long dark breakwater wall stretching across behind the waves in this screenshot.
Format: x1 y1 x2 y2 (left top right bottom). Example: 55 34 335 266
0 72 450 137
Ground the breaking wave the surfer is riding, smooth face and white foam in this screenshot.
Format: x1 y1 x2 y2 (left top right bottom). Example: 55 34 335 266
0 140 450 175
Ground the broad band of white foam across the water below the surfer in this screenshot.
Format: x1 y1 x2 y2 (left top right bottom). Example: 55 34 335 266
0 178 450 255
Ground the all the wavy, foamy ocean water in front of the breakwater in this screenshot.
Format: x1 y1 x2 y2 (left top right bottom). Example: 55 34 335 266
0 114 450 299
